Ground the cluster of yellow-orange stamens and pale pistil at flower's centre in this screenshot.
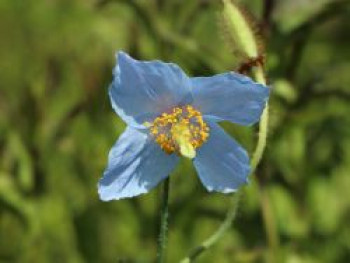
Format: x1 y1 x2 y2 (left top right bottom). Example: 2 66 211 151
150 105 209 159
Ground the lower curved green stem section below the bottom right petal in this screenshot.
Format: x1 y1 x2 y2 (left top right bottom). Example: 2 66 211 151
180 191 241 263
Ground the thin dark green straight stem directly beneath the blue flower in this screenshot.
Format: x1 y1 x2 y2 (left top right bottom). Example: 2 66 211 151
157 177 170 263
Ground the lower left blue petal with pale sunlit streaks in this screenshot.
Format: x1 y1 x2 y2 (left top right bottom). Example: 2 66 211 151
98 127 178 201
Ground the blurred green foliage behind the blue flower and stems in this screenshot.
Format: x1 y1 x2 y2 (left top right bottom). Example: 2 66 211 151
0 0 350 263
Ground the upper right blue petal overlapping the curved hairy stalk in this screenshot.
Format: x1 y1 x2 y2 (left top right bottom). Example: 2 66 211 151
191 73 269 125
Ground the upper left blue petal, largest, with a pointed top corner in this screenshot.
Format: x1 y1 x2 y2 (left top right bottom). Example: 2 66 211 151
109 52 193 127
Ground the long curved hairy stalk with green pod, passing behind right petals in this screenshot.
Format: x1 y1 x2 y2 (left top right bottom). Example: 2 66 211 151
181 0 269 263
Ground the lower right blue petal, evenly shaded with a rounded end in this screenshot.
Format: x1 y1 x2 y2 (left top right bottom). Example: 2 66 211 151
193 122 250 193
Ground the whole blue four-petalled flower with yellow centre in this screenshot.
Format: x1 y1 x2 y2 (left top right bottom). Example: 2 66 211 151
98 52 269 201
